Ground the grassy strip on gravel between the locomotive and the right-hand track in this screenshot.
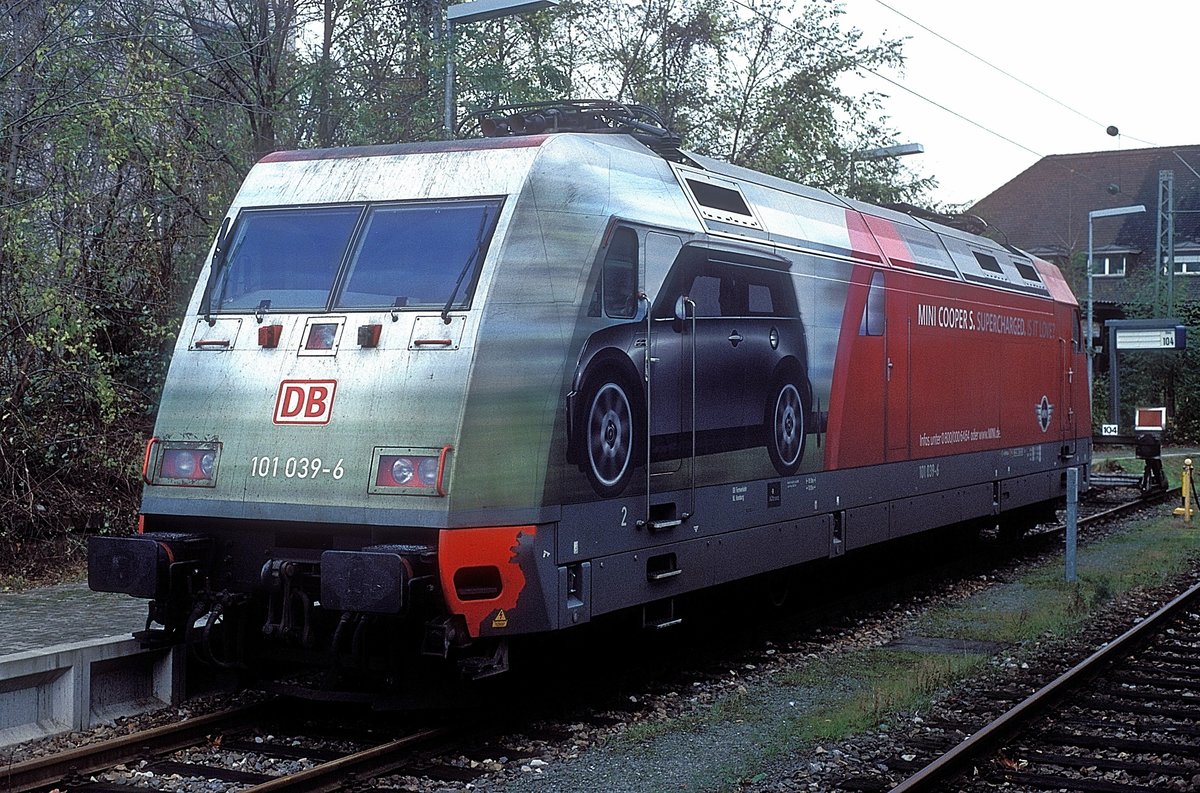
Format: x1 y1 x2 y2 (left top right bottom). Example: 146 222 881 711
597 503 1200 789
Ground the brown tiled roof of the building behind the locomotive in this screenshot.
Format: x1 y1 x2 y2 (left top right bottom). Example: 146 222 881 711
967 145 1200 258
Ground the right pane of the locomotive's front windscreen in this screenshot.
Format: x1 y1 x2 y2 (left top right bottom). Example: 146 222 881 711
336 200 499 311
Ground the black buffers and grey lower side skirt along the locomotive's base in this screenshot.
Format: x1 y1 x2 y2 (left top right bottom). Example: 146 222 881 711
90 440 1090 679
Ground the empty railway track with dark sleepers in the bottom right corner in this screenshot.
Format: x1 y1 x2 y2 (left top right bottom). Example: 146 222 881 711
893 575 1200 793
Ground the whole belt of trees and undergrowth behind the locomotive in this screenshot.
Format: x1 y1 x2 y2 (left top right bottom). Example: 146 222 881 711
0 0 936 575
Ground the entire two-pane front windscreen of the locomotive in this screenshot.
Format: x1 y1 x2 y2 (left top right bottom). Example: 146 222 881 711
204 199 500 313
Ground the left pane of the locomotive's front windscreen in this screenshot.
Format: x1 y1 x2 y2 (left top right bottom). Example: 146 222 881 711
209 206 362 313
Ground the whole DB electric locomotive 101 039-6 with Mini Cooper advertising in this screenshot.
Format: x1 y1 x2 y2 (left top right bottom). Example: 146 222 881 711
89 98 1091 678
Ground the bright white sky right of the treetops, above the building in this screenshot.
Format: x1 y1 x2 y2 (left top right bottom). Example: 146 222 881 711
841 0 1200 205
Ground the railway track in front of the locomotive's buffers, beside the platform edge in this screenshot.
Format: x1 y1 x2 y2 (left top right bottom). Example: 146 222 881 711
0 699 450 793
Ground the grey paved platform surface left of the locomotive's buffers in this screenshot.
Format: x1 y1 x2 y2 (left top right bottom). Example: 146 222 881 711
0 581 148 657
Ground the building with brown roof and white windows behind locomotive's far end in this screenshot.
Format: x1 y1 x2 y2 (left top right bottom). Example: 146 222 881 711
967 145 1200 438
